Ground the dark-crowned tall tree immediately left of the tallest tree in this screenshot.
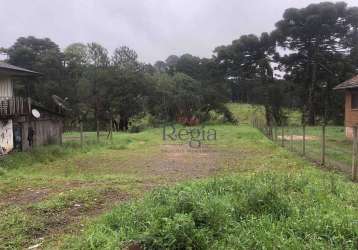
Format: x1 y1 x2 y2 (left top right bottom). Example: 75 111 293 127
215 33 281 124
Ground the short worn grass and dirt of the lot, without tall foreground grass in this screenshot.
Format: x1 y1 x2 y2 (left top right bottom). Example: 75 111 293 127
0 125 271 249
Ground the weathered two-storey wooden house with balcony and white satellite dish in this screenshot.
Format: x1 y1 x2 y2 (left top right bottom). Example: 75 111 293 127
0 62 63 155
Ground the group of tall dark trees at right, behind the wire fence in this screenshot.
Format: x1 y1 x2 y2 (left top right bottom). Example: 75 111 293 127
216 2 358 124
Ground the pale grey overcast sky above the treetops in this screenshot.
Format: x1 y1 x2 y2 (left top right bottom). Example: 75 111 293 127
0 0 358 63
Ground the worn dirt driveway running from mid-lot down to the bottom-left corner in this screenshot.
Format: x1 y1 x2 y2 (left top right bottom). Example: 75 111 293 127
0 144 243 249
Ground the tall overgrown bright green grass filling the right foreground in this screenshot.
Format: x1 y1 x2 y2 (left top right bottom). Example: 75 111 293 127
64 167 358 249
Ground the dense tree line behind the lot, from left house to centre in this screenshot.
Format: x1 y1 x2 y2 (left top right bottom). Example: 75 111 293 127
2 39 232 130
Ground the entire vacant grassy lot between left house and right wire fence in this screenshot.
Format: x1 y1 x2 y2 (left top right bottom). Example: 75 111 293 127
0 118 358 249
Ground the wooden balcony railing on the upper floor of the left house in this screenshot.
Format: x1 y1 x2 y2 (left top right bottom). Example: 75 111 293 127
0 97 31 118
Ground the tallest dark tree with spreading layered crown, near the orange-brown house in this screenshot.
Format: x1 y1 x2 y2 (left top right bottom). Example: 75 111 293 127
274 2 348 124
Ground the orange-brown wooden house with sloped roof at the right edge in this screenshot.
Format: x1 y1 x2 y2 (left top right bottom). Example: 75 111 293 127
334 75 358 139
